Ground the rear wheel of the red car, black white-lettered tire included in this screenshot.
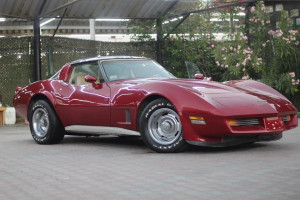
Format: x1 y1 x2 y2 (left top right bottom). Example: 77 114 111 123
29 100 65 144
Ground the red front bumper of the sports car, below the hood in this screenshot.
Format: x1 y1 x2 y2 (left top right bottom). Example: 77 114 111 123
182 114 298 146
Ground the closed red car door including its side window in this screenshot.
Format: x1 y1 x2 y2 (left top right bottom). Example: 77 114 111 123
56 63 110 126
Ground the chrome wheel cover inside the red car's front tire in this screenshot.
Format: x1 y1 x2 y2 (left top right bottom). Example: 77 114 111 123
148 108 182 145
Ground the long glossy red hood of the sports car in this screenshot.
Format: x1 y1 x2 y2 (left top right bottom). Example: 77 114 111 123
123 79 297 116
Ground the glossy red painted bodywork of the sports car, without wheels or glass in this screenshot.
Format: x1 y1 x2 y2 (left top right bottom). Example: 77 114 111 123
13 58 298 147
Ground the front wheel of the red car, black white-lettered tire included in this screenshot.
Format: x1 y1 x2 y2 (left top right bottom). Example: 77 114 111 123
139 98 187 153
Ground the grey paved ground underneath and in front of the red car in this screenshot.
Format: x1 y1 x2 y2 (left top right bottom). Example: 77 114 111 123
0 121 300 200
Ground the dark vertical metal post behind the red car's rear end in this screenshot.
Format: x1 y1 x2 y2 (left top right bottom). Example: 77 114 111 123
33 18 42 81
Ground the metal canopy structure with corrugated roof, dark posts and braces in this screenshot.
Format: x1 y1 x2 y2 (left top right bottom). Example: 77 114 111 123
0 0 258 80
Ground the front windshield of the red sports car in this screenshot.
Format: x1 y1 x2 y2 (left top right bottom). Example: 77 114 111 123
102 60 175 81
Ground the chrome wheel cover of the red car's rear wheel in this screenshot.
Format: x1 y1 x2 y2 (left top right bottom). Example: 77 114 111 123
32 108 49 138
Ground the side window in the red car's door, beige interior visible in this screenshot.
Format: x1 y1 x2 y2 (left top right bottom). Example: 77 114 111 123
69 63 103 85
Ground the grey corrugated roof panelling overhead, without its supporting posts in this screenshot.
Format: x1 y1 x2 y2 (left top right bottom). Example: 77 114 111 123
0 0 196 19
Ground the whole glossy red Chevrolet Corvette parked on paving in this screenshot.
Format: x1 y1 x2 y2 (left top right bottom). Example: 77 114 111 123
13 57 298 152
